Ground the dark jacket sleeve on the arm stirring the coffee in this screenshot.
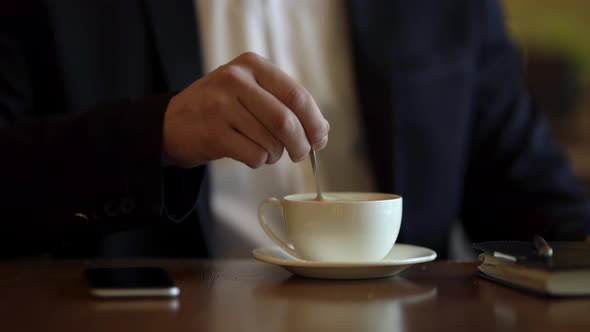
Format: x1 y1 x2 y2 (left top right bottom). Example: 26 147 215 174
0 2 203 243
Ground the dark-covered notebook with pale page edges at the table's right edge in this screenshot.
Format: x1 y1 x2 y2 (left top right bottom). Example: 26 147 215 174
473 241 590 297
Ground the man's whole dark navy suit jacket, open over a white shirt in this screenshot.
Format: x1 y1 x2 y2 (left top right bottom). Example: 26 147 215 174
0 0 590 257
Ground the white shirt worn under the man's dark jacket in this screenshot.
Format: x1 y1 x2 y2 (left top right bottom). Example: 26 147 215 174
195 0 374 257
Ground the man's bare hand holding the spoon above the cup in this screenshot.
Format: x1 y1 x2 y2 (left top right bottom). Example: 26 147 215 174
163 53 329 168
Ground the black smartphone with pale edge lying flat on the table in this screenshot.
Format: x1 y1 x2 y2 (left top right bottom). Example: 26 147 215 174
84 267 180 298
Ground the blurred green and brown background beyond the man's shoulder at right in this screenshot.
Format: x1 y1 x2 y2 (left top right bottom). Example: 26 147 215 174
503 0 590 189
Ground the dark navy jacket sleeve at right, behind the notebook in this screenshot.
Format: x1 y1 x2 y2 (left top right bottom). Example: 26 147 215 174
463 0 590 241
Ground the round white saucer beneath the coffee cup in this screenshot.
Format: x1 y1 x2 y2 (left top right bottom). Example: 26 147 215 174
252 244 436 279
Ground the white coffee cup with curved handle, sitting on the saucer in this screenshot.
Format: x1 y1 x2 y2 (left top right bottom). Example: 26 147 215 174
258 192 402 262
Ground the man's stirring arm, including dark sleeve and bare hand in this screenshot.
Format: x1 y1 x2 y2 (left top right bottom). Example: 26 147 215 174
0 2 329 246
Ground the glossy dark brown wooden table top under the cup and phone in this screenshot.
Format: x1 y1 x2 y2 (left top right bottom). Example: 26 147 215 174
0 260 590 332
